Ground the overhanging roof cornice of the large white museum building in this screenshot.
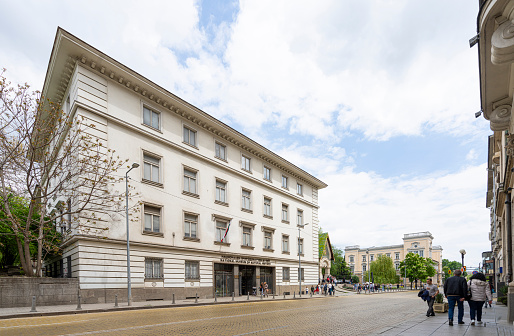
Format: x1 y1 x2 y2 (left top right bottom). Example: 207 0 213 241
43 28 327 189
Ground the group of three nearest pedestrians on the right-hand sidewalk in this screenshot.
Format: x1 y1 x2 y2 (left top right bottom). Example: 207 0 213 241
423 270 492 326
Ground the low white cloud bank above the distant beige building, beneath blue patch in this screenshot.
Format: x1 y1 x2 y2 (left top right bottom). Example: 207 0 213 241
320 164 490 265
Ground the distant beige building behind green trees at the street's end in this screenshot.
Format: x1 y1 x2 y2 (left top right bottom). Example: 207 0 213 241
344 231 443 284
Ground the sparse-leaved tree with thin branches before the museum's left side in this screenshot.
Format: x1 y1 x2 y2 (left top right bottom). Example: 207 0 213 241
0 69 132 276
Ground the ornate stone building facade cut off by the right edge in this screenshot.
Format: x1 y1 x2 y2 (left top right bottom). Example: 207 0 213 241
476 0 514 289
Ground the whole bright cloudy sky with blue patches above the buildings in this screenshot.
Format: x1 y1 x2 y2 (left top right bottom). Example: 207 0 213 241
0 0 491 267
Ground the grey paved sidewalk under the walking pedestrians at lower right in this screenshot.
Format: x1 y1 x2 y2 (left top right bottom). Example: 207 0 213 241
374 302 514 336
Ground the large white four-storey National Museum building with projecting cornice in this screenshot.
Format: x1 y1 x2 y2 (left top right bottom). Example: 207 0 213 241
43 28 327 302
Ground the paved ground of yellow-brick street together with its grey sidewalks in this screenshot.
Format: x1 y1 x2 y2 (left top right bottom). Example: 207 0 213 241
0 292 514 336
